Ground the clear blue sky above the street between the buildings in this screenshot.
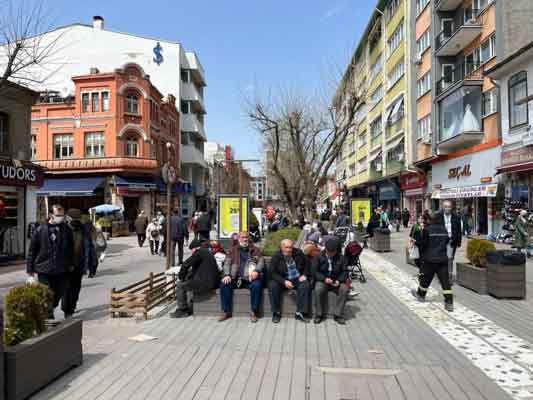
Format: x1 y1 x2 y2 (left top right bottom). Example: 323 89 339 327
50 0 375 161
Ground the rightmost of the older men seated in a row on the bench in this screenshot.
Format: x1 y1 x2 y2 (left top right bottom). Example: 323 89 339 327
312 239 350 325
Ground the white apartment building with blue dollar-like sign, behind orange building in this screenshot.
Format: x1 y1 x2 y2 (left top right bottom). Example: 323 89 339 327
0 16 207 210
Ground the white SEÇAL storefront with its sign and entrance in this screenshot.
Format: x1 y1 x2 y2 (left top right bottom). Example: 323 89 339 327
432 147 504 235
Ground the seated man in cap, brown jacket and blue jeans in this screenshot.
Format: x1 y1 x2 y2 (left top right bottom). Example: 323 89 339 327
218 232 265 322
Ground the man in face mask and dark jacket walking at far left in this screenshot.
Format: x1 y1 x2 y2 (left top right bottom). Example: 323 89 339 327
26 204 74 319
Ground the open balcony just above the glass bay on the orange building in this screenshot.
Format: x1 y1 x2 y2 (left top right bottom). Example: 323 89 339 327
435 9 481 57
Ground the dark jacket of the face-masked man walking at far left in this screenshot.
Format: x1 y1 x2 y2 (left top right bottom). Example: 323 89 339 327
26 223 74 275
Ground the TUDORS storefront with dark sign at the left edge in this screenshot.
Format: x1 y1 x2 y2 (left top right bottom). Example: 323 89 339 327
0 159 43 265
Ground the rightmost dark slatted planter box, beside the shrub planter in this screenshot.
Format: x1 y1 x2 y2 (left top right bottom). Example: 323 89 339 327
487 263 526 299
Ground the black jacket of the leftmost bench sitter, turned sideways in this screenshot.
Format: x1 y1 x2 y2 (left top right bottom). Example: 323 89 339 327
178 247 220 293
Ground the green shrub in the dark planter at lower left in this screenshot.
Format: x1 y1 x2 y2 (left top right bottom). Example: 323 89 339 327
4 284 53 346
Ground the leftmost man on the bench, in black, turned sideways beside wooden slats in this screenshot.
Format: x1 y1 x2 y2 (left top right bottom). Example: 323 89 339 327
170 241 220 318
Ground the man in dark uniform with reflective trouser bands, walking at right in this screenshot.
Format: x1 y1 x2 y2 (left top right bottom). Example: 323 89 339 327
412 213 453 311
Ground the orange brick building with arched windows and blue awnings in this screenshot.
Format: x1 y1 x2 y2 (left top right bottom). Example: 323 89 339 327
31 63 181 225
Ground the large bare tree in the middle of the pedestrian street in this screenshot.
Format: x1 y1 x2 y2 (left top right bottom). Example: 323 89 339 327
247 74 361 216
